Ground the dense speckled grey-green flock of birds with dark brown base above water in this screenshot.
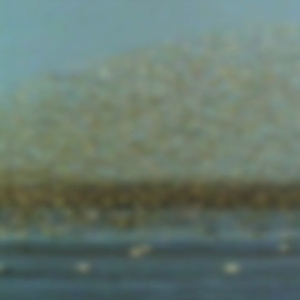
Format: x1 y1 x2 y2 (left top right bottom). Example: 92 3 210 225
0 27 300 230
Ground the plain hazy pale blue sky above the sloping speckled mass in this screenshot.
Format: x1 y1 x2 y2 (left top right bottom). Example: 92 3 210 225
0 0 300 95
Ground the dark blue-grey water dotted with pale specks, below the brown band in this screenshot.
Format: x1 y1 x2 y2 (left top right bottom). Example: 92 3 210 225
0 211 300 300
